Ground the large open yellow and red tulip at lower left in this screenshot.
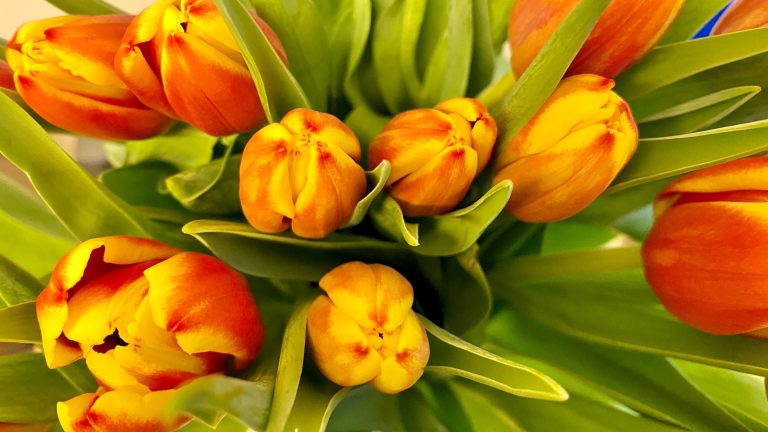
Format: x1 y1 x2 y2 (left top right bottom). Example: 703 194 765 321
37 237 264 430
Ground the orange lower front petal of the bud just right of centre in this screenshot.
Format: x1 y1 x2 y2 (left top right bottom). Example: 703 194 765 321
389 146 477 217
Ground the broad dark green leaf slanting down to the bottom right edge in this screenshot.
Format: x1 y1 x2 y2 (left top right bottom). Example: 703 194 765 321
488 308 747 432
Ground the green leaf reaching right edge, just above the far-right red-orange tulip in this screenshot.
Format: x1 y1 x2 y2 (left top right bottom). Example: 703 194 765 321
608 118 768 193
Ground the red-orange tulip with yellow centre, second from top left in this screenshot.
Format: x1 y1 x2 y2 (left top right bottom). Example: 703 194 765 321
115 0 285 136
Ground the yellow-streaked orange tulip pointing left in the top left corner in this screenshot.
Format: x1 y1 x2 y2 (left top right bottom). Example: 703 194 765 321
0 15 172 140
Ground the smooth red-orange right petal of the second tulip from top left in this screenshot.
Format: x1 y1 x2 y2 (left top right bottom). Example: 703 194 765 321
160 33 265 136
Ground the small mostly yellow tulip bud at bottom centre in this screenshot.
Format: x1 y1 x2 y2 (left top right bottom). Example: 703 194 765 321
307 261 429 393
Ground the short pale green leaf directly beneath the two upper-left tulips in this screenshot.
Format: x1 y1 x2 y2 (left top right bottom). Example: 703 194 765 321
105 124 216 169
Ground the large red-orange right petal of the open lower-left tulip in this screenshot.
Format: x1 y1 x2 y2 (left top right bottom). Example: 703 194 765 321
144 252 264 369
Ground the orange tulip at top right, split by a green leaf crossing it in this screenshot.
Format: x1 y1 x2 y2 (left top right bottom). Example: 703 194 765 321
509 0 685 78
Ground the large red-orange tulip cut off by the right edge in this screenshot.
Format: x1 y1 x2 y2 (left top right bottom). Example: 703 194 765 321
643 157 768 337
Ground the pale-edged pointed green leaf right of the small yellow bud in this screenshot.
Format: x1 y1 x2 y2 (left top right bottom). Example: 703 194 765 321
421 317 568 401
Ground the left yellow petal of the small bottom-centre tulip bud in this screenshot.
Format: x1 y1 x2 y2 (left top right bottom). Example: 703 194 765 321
307 296 382 386
